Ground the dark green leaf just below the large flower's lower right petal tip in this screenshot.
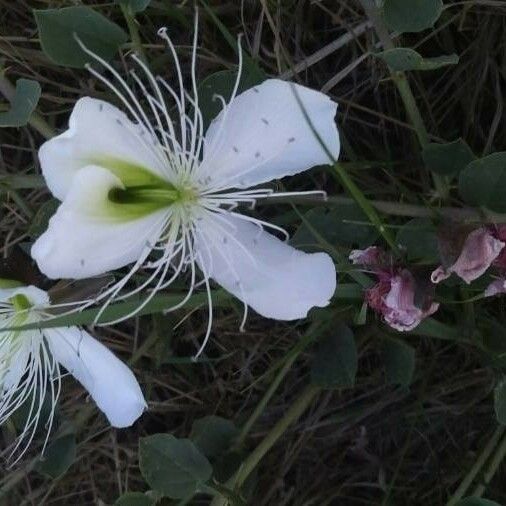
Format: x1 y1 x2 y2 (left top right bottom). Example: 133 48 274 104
311 322 358 388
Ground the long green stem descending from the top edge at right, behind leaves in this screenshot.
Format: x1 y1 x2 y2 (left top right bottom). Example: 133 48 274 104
360 0 449 199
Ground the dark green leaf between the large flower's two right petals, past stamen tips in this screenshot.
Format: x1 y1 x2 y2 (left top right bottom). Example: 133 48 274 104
291 202 378 248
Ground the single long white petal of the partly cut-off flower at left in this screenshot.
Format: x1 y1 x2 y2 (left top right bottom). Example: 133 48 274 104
43 327 146 427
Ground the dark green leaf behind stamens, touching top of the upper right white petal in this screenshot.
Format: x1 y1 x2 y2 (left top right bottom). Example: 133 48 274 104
198 67 266 126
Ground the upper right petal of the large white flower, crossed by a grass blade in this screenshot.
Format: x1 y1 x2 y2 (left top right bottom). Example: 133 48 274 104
200 79 340 188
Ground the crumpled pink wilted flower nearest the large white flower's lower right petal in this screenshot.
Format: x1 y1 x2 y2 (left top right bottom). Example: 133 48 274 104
349 247 439 332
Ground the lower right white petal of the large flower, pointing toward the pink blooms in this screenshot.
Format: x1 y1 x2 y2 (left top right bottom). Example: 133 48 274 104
196 216 336 320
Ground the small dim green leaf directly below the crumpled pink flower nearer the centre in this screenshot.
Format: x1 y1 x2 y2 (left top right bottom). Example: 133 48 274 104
382 339 415 387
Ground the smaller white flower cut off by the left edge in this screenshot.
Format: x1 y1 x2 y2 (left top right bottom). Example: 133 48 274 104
0 285 146 453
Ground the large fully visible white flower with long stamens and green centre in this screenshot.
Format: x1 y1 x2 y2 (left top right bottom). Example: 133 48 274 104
32 21 340 354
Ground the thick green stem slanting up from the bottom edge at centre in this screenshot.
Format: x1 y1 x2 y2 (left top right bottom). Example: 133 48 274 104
211 385 320 506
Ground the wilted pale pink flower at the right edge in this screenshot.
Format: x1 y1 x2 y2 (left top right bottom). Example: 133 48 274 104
430 227 506 284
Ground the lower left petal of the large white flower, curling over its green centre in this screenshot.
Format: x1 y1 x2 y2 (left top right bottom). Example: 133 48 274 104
31 166 165 279
